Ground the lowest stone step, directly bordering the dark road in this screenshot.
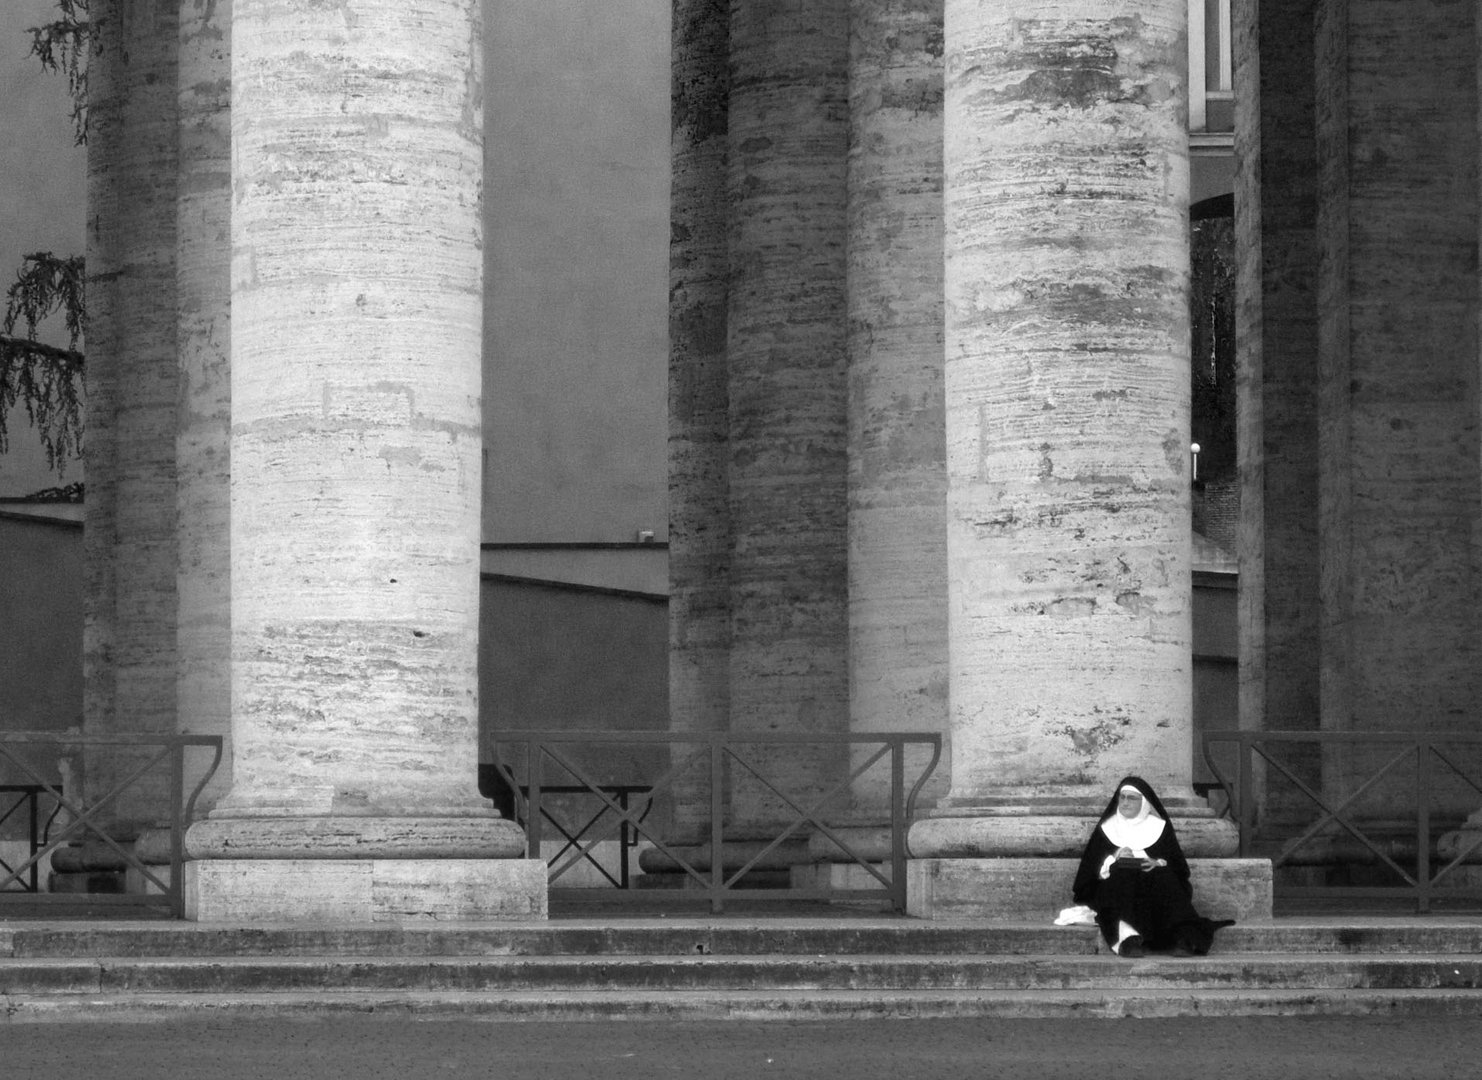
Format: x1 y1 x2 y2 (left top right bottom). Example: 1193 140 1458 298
0 987 1482 1024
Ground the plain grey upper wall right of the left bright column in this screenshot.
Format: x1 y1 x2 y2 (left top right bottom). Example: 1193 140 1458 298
483 0 670 542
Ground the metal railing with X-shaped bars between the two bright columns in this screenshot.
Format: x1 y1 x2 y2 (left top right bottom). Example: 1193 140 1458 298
494 730 941 913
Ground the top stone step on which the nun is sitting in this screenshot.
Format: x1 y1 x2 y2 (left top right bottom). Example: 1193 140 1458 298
11 917 1482 957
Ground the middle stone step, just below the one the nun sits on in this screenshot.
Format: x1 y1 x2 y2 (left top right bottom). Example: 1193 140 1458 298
0 954 1482 1004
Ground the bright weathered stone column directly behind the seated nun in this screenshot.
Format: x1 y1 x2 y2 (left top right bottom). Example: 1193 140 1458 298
911 0 1233 911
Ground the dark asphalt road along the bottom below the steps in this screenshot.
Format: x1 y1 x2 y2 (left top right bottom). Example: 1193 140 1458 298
0 1016 1482 1080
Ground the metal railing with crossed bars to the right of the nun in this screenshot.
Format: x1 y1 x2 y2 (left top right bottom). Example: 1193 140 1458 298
1203 730 1482 913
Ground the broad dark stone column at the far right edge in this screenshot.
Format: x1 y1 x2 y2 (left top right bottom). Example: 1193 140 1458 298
1316 0 1482 827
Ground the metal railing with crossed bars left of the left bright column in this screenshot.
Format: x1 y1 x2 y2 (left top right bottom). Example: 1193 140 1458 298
0 732 222 919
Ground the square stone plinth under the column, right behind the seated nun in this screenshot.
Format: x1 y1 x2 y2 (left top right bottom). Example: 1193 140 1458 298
906 859 1272 923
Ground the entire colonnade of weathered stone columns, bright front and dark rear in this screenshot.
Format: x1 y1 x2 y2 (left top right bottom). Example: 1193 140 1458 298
86 0 1482 919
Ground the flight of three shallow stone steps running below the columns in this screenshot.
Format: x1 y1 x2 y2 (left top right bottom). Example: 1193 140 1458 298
0 917 1482 1022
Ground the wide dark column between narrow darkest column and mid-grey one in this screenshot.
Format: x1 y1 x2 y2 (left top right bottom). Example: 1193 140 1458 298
726 0 849 825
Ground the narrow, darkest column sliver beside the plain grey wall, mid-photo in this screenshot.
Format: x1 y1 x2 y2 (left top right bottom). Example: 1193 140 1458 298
668 0 731 841
